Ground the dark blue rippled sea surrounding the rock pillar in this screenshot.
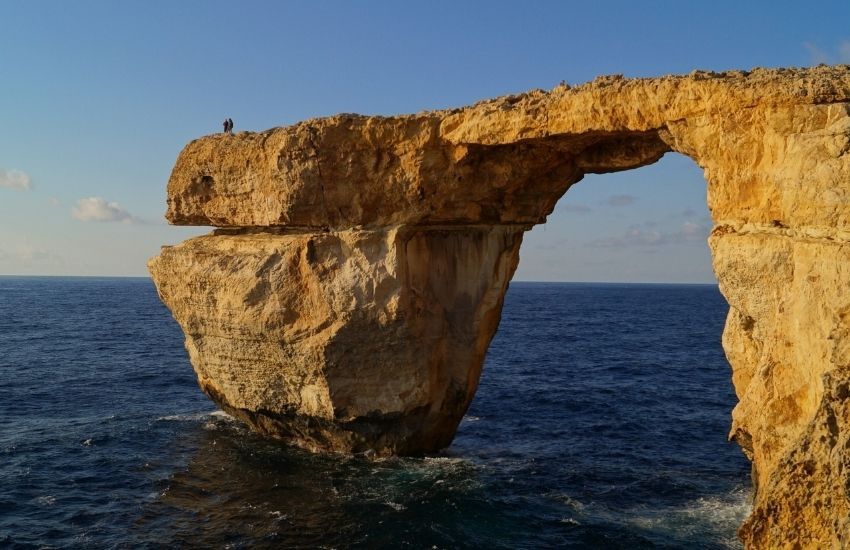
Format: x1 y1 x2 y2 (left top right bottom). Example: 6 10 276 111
0 277 749 549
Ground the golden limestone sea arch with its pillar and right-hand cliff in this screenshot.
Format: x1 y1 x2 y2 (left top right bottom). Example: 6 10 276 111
149 66 850 548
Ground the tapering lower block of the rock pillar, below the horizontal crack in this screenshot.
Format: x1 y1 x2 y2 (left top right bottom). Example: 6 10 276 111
150 226 522 455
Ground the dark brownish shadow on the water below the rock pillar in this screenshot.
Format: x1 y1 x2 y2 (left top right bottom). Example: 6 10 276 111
133 416 499 548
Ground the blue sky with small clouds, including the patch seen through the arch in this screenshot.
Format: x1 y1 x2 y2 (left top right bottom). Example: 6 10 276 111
0 0 850 283
